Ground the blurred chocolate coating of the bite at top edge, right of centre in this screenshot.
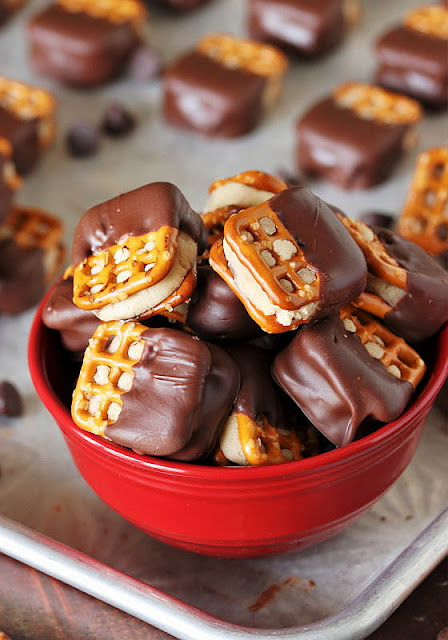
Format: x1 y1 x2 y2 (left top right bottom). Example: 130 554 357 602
248 0 345 56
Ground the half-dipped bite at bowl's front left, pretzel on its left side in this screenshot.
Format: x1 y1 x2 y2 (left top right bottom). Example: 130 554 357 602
72 321 240 461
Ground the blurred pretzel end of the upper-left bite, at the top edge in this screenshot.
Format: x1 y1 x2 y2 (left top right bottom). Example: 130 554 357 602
58 0 146 24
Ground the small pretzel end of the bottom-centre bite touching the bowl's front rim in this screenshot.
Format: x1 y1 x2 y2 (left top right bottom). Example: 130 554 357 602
237 413 303 465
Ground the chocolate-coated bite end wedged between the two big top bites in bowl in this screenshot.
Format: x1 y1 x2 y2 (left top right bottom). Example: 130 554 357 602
187 265 262 342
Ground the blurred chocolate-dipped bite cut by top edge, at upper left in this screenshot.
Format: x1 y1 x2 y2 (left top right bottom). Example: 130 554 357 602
28 0 147 87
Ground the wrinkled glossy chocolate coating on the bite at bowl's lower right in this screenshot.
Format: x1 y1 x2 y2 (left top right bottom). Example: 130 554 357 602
272 313 413 446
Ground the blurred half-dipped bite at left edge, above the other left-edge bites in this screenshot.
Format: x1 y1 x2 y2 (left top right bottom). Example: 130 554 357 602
0 76 56 175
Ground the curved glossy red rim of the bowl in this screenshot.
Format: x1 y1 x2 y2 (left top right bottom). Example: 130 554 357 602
28 287 448 481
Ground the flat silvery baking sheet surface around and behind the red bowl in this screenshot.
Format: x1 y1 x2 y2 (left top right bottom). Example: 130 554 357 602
0 0 448 638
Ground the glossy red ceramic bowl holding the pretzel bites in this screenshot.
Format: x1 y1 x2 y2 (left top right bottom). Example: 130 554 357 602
28 292 448 557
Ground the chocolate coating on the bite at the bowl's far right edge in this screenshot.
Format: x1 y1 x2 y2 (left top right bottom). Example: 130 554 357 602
374 227 448 342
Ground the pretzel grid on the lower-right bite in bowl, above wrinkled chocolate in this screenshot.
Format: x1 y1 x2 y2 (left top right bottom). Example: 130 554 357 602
339 305 426 389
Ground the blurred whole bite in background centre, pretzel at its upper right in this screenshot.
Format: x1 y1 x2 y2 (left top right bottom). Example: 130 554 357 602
163 34 288 138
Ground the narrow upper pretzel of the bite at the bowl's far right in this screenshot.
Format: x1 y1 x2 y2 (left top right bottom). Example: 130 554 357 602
337 214 408 289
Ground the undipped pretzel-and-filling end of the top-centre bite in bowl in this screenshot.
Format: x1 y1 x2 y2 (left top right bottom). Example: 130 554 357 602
210 203 320 333
